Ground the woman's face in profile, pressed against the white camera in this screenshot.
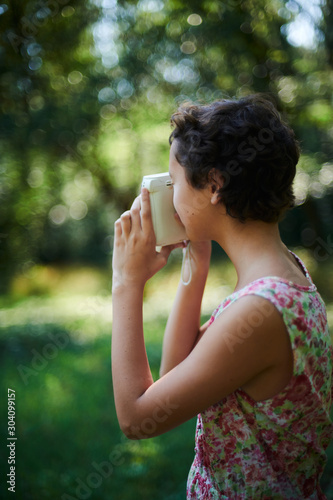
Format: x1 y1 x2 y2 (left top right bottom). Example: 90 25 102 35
169 140 212 241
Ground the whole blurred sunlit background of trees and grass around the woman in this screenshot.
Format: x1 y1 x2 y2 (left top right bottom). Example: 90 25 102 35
0 0 333 500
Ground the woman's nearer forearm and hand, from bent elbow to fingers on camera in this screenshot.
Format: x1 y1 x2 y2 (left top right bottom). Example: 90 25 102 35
112 190 183 428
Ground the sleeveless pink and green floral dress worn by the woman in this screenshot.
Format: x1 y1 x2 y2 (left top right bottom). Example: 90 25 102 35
187 254 333 500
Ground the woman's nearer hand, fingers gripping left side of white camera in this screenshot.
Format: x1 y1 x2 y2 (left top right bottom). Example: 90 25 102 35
112 189 184 290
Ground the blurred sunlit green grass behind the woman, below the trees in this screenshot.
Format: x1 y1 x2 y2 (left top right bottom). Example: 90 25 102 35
0 252 333 500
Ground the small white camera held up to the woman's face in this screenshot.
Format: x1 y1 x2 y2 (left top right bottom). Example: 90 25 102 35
142 172 187 246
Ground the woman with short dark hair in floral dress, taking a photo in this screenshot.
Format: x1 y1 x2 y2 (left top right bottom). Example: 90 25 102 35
112 95 333 499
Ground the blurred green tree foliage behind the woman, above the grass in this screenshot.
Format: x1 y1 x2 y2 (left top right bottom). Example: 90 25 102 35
0 0 333 292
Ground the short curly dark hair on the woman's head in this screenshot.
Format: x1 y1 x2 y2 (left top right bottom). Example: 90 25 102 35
169 94 300 222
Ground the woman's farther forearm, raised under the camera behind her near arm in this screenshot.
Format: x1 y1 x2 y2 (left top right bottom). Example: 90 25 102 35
160 242 211 376
